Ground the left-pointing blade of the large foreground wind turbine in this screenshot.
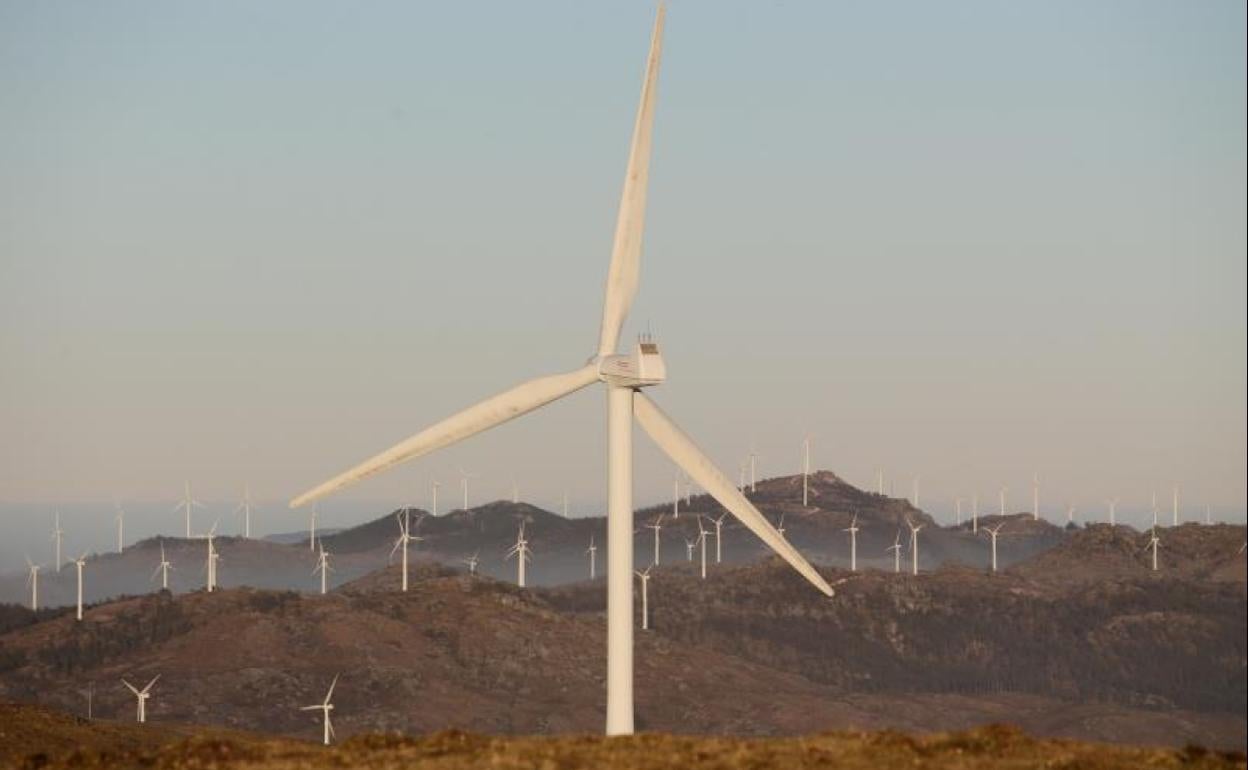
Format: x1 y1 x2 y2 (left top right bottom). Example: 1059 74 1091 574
291 364 598 508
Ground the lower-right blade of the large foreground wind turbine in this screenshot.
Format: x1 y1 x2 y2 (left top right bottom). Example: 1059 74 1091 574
633 392 834 597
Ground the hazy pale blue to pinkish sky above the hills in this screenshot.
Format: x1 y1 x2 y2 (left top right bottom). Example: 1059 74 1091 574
0 0 1248 559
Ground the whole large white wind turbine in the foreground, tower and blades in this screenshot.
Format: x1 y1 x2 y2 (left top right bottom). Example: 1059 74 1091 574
283 6 832 735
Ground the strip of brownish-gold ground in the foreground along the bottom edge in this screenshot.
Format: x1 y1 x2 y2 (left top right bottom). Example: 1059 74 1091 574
0 704 1246 770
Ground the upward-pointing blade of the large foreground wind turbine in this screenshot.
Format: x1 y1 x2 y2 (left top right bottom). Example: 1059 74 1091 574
598 5 665 356
